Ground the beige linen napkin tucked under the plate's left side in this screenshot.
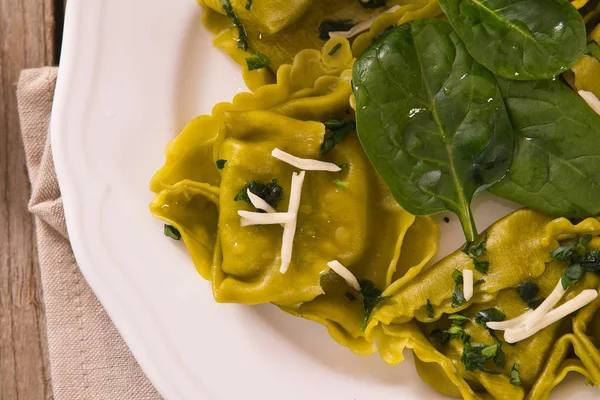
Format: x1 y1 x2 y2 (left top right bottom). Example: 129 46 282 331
17 68 160 400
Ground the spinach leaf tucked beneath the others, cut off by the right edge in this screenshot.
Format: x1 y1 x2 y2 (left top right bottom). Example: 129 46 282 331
489 78 600 218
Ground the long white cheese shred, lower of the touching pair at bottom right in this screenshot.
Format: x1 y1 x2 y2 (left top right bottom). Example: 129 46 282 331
504 289 598 343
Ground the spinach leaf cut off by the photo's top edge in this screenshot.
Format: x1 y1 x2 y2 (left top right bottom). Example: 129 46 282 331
440 0 586 80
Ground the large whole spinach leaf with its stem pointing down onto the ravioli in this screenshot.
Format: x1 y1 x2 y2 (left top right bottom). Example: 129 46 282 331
353 20 513 242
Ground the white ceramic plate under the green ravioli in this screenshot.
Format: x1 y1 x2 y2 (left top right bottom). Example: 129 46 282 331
51 0 597 400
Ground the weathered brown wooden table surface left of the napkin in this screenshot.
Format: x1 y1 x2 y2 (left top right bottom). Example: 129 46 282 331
0 0 64 400
